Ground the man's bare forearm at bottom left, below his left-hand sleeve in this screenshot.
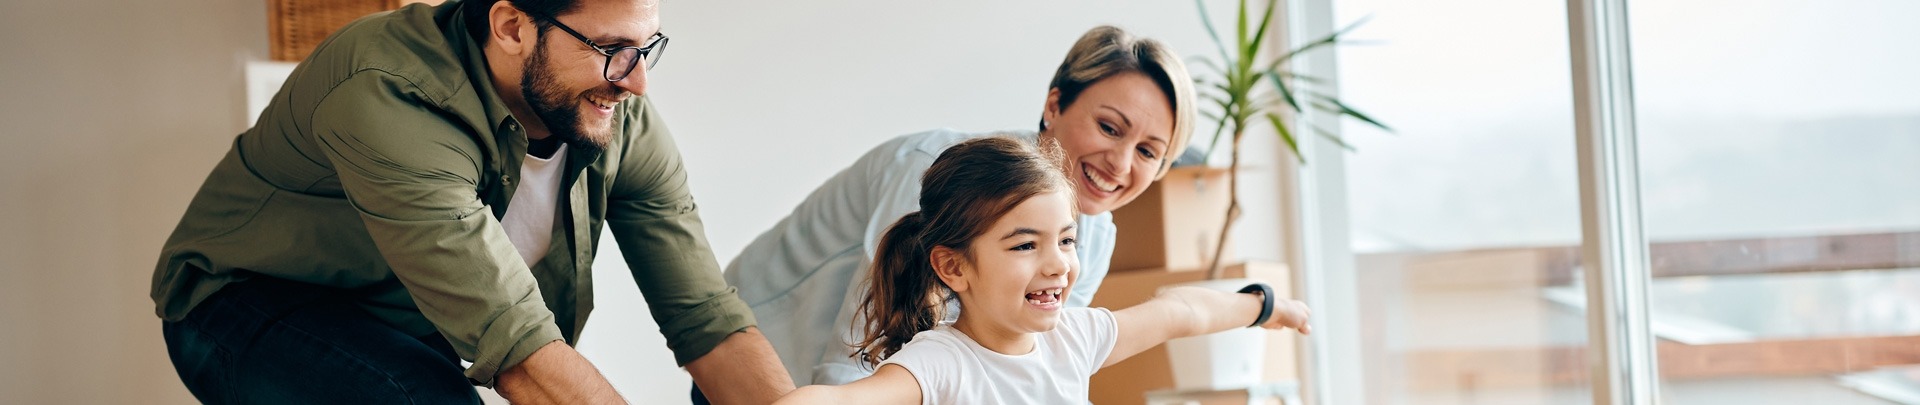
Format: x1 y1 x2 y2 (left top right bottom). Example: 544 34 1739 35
495 340 626 403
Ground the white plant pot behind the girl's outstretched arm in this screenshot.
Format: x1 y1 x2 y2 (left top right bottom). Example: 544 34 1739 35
1162 278 1267 390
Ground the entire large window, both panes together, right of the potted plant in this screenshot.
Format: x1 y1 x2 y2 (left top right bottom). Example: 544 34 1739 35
1296 0 1920 403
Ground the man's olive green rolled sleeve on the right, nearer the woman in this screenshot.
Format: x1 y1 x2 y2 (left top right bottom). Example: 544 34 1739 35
607 98 755 367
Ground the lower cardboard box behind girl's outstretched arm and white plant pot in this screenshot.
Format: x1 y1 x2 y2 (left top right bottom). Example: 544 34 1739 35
1089 261 1300 405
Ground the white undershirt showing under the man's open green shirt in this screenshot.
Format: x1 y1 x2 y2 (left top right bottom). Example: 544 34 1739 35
499 144 566 267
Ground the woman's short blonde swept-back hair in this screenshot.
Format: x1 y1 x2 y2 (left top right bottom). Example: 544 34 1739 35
1041 25 1196 180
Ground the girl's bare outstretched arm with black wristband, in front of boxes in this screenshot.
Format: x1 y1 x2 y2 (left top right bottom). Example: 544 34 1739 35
1100 286 1311 369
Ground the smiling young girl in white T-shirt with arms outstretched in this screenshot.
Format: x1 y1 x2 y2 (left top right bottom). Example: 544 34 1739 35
781 136 1308 405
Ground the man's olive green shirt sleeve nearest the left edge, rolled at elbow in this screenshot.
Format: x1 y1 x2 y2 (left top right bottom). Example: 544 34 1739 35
311 71 561 386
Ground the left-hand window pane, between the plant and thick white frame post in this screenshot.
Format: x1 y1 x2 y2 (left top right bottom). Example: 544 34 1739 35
1336 0 1592 403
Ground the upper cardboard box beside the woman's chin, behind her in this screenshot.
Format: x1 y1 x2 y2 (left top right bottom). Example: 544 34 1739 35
1110 167 1233 271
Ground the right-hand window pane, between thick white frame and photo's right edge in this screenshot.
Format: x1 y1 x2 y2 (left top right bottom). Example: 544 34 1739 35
1628 0 1920 405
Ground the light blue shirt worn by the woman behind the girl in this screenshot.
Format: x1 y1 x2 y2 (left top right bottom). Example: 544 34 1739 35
726 129 1116 386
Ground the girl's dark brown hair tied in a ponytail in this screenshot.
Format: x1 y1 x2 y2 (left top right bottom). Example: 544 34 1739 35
854 136 1073 365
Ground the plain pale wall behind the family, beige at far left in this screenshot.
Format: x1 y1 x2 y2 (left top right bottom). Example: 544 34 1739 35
0 0 1277 403
